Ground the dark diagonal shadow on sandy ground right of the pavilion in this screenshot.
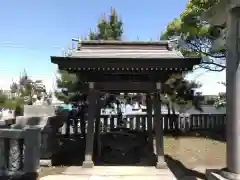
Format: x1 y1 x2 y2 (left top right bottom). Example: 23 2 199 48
165 155 205 180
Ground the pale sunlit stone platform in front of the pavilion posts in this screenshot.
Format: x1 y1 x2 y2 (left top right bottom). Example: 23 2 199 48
40 166 176 180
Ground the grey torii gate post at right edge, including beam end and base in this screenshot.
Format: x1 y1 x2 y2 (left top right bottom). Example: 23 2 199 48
202 0 240 180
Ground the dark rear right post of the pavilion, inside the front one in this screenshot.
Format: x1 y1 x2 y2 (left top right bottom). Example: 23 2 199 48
146 93 153 152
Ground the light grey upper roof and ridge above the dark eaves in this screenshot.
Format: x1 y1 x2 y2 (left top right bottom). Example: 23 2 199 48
69 41 184 59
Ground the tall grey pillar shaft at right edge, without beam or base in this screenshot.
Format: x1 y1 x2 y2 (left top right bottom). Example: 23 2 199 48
226 8 240 176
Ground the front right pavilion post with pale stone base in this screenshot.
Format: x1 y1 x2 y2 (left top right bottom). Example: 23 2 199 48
154 82 166 169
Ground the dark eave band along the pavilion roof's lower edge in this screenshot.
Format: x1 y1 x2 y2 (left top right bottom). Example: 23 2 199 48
51 56 201 70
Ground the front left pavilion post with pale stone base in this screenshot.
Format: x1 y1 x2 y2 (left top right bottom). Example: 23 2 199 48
82 82 96 168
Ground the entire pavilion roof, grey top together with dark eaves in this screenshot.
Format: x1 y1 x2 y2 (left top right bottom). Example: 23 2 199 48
51 40 201 77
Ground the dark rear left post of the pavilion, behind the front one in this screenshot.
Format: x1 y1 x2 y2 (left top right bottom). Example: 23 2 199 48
94 93 101 160
